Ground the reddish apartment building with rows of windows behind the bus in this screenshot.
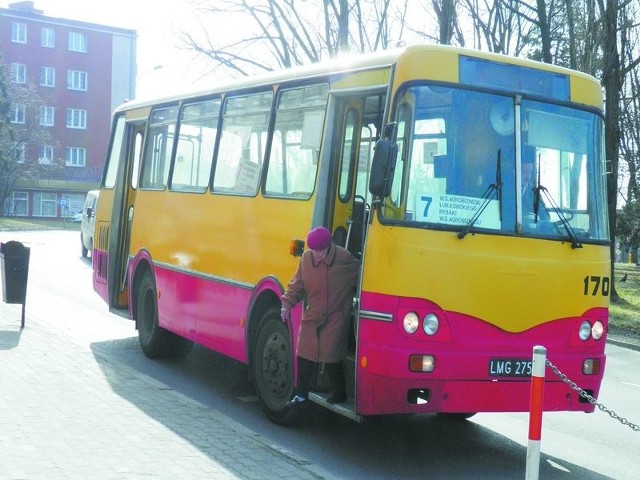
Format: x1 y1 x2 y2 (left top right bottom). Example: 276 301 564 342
0 1 137 218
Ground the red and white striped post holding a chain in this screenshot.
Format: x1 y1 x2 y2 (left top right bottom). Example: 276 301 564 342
525 345 547 480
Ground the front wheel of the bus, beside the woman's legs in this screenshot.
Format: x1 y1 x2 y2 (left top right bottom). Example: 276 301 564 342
252 309 299 425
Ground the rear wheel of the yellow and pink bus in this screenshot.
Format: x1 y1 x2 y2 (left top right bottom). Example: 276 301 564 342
136 274 193 358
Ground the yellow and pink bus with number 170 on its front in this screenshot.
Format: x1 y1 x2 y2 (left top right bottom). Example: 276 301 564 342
93 45 611 424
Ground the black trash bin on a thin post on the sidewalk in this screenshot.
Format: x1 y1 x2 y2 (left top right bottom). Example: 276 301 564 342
0 240 30 327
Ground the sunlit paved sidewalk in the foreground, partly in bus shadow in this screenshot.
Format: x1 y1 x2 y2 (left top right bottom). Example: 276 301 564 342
0 302 332 480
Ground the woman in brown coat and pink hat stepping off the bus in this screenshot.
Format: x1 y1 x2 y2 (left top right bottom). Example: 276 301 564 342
281 227 360 406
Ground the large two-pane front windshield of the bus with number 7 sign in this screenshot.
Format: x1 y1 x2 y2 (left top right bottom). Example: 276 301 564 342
382 85 609 246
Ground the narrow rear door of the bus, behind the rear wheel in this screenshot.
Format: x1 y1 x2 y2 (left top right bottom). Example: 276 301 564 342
107 118 146 311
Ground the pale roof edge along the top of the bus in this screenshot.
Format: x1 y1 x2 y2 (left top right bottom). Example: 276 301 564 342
115 44 599 113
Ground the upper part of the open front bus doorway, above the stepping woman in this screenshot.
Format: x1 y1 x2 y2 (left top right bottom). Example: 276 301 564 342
328 93 385 258
